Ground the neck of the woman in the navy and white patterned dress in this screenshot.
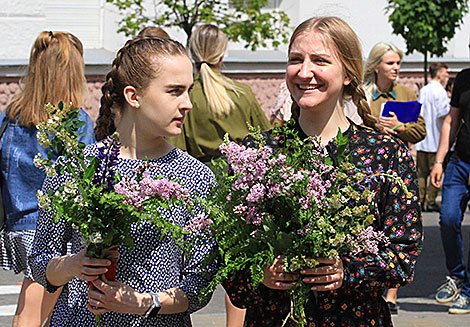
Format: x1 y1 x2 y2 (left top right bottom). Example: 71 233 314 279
116 110 174 160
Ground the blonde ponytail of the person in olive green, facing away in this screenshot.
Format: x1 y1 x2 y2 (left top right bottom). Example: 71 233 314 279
189 24 243 115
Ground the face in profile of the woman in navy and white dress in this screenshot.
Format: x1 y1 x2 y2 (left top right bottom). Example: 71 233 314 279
136 56 193 137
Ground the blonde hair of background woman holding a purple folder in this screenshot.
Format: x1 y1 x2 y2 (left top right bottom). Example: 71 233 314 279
364 42 403 100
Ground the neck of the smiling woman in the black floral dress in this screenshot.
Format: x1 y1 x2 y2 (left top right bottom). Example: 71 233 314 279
299 105 351 145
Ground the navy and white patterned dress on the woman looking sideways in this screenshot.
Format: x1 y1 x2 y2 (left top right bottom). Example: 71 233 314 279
30 144 216 327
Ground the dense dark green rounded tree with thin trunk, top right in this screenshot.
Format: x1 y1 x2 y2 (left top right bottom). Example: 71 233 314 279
386 0 468 83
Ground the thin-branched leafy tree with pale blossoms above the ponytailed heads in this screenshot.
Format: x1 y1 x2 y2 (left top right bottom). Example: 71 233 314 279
106 0 290 50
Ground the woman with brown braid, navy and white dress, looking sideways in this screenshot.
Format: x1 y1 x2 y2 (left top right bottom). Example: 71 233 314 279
31 37 216 327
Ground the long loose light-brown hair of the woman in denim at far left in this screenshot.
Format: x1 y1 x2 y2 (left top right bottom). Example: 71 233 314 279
6 32 86 127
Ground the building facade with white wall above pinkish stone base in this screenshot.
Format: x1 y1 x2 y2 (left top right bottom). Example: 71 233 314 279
0 0 470 119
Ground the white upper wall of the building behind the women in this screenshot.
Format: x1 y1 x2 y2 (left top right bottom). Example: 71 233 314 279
0 0 470 61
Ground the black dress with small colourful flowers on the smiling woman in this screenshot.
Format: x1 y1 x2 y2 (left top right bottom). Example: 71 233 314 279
224 123 423 327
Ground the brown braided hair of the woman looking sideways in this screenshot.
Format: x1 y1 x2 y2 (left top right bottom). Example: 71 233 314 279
95 36 188 141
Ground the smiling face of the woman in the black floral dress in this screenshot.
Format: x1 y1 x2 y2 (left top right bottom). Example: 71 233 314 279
286 31 350 110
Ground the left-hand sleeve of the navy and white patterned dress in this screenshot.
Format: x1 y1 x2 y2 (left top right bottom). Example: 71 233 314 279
28 176 72 293
